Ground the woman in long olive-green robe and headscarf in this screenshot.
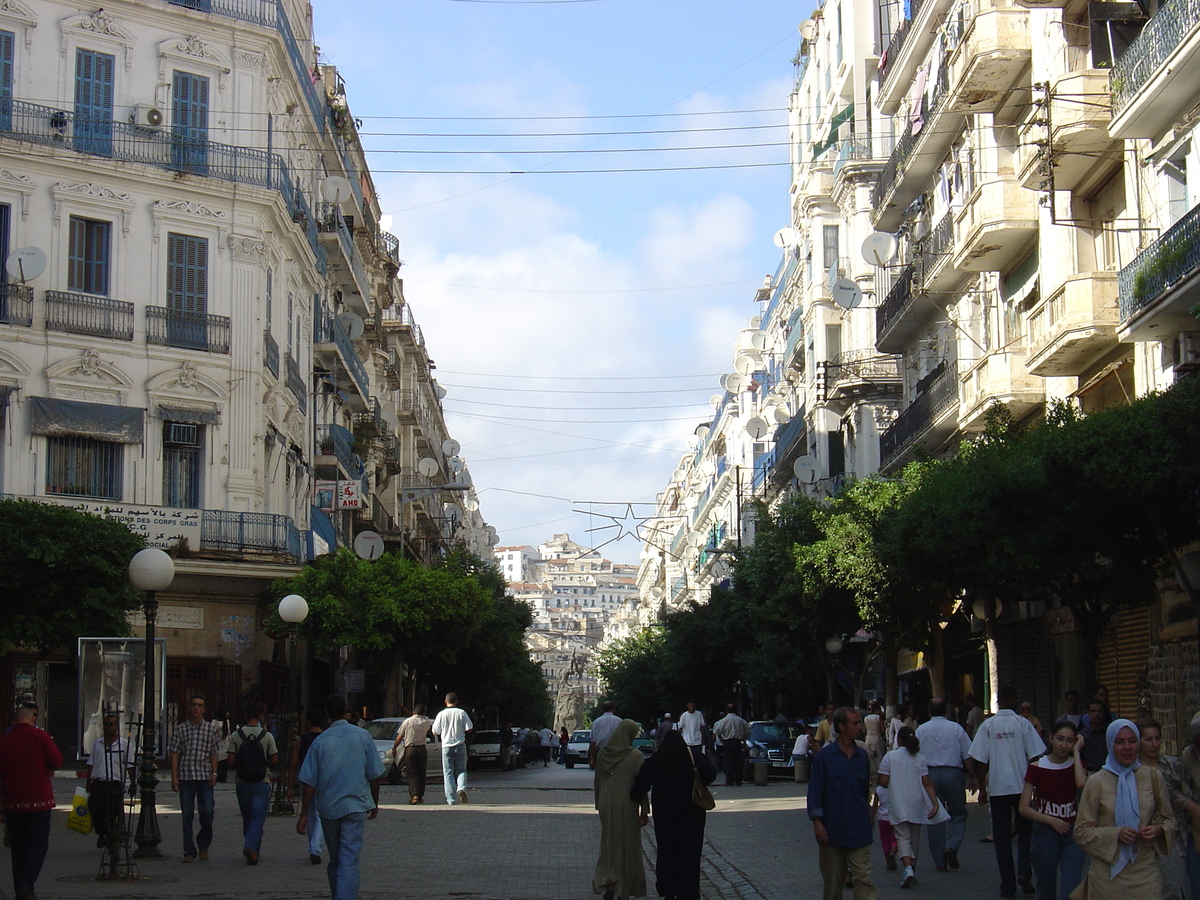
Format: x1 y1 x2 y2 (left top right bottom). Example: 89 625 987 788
592 719 650 900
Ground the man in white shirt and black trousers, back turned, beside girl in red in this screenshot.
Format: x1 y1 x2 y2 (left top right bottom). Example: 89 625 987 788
964 684 1046 898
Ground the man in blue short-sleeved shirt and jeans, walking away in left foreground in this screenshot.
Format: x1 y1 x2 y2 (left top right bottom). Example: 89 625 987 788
296 694 384 900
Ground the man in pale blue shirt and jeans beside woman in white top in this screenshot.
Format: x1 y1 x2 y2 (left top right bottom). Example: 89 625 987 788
917 697 971 872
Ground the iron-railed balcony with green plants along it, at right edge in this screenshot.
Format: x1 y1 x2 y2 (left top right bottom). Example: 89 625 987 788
1117 200 1200 341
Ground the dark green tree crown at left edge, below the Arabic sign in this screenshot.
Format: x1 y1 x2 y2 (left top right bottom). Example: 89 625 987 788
0 500 145 649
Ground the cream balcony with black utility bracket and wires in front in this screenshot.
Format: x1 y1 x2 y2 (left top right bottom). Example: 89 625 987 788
1018 68 1122 191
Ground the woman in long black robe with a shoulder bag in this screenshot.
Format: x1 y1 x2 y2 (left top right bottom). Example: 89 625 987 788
629 731 716 900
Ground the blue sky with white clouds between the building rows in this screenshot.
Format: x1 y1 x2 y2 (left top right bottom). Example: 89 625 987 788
313 0 810 563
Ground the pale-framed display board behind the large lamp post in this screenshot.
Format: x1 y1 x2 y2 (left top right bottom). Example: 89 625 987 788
79 637 167 758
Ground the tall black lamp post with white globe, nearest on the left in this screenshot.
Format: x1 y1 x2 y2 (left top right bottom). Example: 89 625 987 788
130 547 175 859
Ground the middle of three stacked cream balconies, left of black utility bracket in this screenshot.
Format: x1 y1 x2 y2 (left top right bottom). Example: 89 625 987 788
954 175 1038 272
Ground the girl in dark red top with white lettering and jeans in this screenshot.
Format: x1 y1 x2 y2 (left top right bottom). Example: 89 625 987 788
1020 719 1087 900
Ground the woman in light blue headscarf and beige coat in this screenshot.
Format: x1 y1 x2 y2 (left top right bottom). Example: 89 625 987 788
1072 719 1175 900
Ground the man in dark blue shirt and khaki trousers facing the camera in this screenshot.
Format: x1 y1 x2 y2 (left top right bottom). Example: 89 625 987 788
808 707 875 900
